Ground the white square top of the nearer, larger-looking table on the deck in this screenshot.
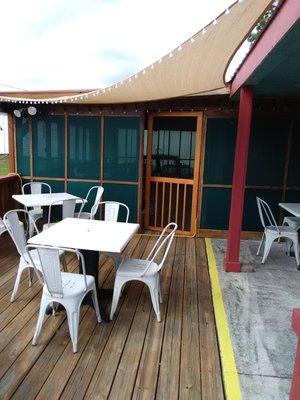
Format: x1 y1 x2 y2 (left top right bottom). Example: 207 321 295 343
28 218 139 253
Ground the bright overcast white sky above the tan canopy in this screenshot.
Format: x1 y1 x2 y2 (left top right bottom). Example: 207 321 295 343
0 0 240 90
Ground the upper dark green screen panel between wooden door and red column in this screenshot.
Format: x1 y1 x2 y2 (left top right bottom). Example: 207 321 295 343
204 118 237 185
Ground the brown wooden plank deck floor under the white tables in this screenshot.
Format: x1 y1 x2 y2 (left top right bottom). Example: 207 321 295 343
0 235 224 400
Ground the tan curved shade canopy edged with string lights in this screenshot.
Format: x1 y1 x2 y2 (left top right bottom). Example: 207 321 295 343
0 0 273 104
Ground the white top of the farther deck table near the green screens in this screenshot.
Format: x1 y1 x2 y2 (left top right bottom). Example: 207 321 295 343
12 193 82 207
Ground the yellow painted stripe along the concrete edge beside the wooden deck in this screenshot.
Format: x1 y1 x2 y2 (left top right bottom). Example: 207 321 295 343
205 239 242 400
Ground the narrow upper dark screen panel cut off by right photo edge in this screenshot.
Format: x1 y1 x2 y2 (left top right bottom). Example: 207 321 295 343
287 120 300 186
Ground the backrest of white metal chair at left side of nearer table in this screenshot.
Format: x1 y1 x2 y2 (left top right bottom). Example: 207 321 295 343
3 209 39 262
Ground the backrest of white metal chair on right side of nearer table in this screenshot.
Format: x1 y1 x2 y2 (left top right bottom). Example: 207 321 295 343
143 222 178 275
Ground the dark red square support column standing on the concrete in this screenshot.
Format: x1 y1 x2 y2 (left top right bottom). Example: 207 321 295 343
225 86 253 272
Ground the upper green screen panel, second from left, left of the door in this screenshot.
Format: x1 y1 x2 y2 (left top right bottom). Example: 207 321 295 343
32 116 64 178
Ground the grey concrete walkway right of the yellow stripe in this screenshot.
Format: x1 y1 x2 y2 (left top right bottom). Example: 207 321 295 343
212 239 300 400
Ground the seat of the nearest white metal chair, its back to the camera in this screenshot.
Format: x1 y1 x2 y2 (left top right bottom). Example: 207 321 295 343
43 272 95 298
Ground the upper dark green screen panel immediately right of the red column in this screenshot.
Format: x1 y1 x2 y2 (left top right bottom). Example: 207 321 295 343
247 118 289 186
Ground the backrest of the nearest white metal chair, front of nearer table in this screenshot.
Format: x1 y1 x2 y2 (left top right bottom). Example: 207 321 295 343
26 245 87 298
